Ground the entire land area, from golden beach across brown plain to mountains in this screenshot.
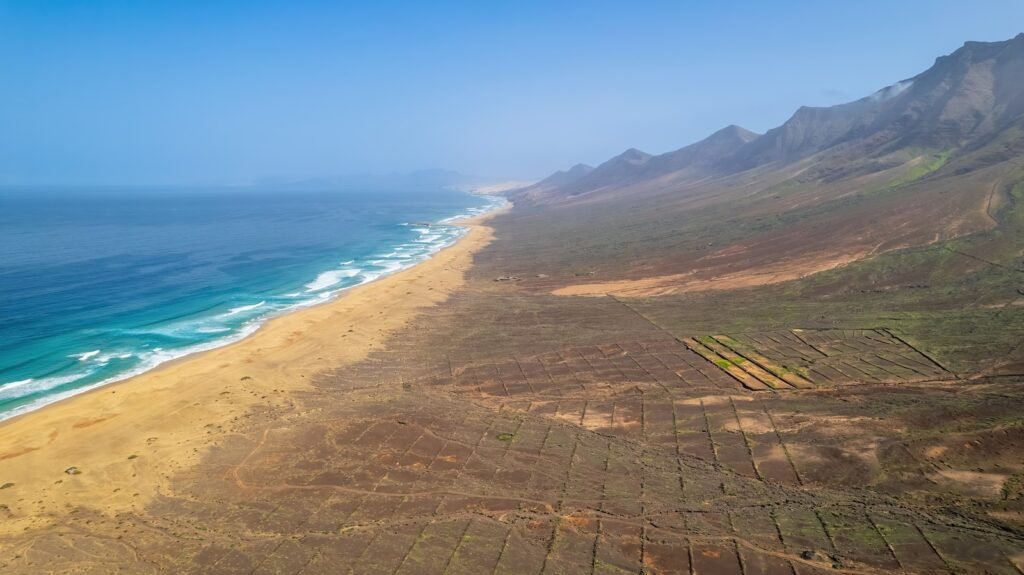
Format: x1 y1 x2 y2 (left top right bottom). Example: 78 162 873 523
0 34 1024 575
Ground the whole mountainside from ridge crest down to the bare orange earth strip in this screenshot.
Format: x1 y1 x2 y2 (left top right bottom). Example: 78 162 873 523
493 35 1024 295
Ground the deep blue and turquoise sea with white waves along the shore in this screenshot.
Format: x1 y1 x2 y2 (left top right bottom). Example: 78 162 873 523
0 188 497 419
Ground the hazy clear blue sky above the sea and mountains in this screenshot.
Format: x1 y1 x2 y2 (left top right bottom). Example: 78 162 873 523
0 0 1024 183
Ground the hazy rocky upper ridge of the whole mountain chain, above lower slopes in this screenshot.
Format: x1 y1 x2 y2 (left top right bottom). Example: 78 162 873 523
523 34 1024 207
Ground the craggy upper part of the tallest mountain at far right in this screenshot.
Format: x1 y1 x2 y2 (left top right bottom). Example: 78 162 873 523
737 34 1024 169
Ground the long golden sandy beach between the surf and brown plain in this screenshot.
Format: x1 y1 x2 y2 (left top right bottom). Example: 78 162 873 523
0 213 494 534
